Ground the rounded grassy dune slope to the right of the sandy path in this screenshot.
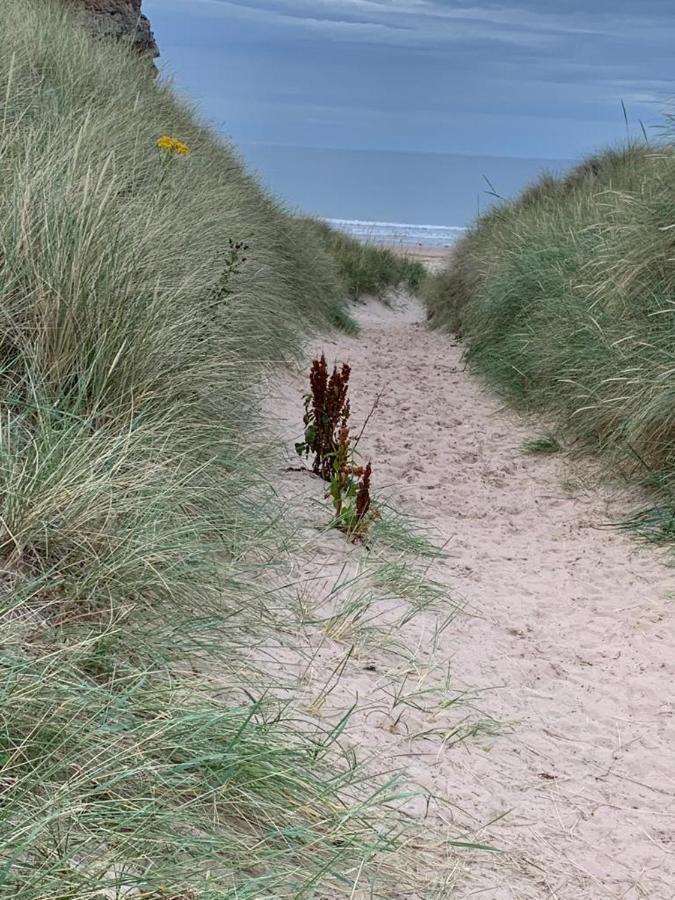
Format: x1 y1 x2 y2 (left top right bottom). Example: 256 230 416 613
425 146 675 533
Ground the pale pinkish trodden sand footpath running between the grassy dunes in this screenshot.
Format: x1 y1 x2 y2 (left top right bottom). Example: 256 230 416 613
268 301 675 900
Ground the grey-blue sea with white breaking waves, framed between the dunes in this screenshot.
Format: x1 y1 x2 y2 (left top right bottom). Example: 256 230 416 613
239 143 574 247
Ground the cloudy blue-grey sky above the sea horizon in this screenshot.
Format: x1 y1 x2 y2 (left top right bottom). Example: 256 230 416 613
144 0 675 160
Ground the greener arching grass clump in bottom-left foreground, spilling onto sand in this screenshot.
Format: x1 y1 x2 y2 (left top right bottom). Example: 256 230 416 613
0 624 418 900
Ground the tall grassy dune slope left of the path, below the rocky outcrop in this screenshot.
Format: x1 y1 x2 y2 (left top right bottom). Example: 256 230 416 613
0 0 422 900
